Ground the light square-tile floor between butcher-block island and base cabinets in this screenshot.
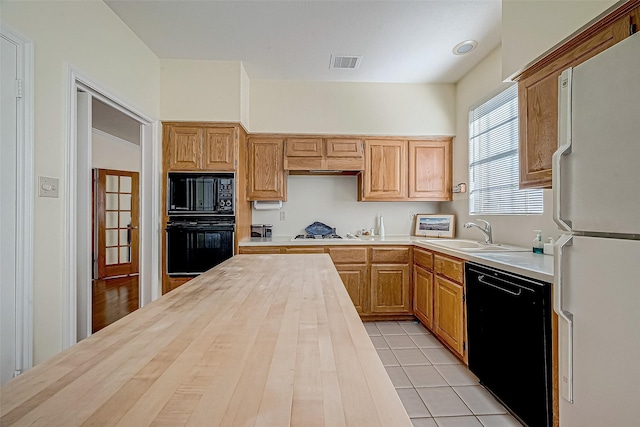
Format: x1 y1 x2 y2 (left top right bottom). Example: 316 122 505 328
364 321 521 427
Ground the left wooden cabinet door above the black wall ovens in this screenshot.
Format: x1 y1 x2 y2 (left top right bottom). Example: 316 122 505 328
165 126 202 170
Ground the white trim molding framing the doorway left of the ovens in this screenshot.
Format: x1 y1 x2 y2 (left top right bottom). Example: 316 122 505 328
62 64 160 348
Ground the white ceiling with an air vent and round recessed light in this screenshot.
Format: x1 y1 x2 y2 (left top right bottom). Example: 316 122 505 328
105 0 501 83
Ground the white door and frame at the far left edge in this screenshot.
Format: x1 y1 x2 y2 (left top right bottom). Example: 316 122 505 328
0 24 35 384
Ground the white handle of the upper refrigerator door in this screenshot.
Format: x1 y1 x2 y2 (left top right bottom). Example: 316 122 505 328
551 68 573 232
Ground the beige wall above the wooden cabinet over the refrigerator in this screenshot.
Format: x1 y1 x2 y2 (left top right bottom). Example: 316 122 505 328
502 0 616 80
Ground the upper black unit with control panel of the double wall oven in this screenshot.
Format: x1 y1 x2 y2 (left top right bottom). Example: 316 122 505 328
167 172 235 216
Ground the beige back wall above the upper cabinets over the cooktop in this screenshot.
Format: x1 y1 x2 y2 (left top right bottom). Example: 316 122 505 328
250 80 455 135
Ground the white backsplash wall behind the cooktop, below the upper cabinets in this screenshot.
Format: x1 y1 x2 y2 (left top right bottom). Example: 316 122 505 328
252 175 440 236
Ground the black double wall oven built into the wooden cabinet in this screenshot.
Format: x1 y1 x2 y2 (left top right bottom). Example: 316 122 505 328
166 172 235 276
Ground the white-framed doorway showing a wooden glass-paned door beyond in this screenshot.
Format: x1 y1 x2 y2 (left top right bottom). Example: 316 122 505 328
63 69 159 348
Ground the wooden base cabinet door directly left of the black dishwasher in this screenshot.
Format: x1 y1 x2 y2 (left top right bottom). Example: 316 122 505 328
433 276 464 357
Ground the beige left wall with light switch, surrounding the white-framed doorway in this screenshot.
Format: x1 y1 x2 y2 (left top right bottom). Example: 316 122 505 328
2 1 160 363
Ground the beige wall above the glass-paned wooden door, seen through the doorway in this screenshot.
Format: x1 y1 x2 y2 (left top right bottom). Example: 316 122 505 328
91 129 140 172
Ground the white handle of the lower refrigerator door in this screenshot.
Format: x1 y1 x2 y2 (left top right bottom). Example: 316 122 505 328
553 234 573 403
